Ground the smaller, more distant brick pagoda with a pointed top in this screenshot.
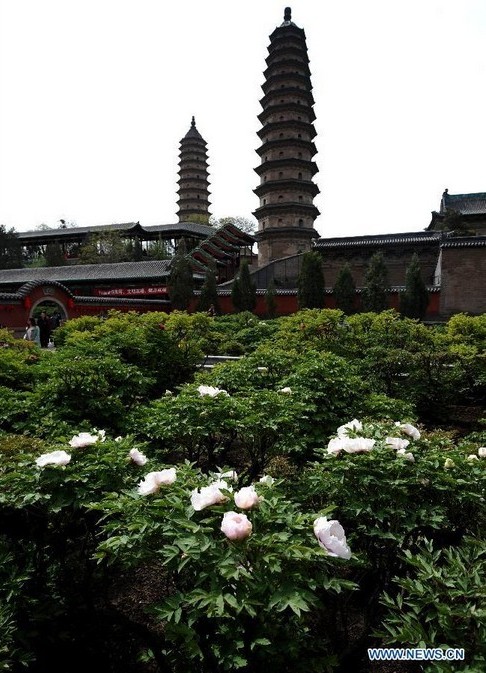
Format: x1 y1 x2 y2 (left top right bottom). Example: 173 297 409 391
177 117 210 222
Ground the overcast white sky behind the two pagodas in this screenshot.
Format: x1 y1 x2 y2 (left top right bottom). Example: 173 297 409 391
0 0 486 236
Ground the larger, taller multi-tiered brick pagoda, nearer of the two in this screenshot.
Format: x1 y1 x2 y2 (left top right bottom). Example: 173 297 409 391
253 7 319 266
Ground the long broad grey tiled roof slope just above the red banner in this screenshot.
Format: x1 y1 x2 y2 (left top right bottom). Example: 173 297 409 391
0 259 170 285
